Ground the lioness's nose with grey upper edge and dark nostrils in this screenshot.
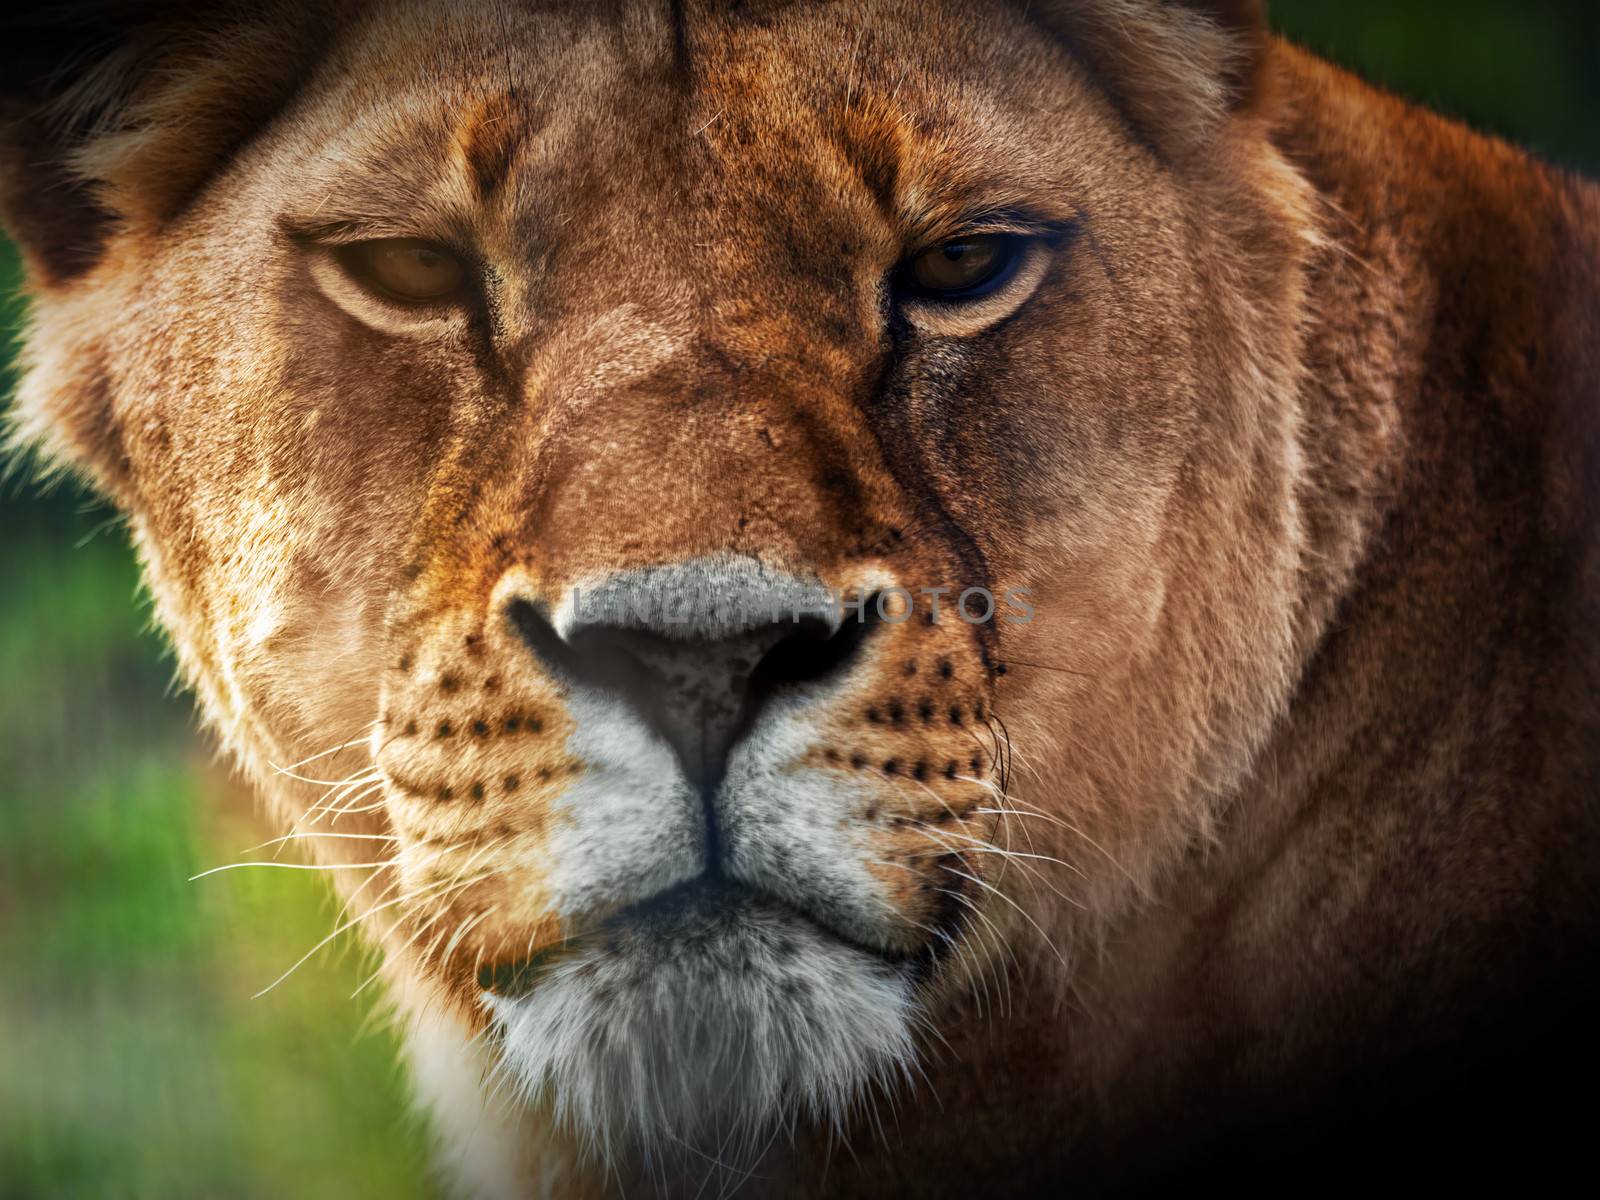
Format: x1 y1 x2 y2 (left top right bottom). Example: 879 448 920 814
507 560 878 794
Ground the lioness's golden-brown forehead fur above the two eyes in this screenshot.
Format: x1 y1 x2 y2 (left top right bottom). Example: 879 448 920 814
272 0 1107 237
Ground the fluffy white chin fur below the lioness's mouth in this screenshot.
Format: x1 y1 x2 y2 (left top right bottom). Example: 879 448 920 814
483 901 915 1160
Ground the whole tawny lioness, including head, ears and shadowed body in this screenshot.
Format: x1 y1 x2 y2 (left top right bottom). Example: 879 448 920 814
3 0 1600 1197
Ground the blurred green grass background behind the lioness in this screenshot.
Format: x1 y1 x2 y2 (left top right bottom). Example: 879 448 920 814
0 0 1600 1200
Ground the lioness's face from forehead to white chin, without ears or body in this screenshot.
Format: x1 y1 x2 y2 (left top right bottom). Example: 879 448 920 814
15 0 1294 1164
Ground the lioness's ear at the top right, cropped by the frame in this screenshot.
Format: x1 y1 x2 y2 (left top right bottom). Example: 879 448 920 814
1029 0 1267 157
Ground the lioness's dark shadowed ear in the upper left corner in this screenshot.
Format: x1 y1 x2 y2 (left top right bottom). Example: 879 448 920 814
0 0 333 288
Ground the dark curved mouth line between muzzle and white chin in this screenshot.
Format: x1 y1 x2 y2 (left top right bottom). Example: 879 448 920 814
478 875 917 998
